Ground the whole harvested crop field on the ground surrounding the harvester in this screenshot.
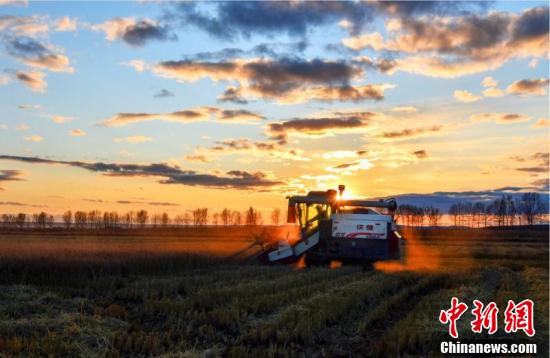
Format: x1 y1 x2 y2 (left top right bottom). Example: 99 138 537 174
0 228 549 357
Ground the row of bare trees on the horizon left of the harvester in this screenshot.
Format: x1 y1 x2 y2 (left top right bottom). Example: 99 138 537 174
1 207 281 229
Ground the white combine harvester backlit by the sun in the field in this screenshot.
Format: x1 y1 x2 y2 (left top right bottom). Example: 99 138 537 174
260 185 401 266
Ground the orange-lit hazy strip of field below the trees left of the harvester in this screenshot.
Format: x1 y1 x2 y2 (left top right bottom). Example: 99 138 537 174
0 226 302 261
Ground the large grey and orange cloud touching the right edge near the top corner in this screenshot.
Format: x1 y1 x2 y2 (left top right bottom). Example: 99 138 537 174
342 6 549 78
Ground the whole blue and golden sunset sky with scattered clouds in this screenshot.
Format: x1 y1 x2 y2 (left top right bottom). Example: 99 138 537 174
0 0 549 213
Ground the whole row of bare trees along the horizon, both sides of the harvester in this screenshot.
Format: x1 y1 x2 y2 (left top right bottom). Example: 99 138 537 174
1 193 548 229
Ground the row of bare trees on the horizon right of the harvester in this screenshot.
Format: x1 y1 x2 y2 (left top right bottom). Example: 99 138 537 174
395 193 548 227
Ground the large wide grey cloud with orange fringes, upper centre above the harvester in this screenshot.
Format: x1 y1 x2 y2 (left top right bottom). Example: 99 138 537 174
138 59 394 103
